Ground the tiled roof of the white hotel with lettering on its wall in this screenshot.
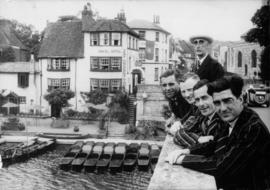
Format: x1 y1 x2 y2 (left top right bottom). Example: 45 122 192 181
83 19 139 37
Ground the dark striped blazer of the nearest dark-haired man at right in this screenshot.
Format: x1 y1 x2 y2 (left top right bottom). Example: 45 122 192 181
182 108 270 189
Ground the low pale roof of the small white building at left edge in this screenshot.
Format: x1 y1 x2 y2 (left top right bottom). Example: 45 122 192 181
0 62 38 73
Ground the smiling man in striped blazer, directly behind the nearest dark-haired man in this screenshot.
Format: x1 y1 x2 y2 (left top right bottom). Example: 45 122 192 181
174 79 227 148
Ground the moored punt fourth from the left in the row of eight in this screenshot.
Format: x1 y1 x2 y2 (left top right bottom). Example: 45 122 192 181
96 142 115 169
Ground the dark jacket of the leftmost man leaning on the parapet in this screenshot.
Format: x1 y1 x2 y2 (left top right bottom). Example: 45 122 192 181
168 91 191 119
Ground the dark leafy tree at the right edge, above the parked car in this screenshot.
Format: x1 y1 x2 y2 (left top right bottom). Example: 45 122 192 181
244 5 270 81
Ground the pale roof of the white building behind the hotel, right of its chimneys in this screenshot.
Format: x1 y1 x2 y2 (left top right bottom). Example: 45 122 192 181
128 20 170 34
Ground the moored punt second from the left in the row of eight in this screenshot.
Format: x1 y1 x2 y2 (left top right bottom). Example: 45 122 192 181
71 141 95 171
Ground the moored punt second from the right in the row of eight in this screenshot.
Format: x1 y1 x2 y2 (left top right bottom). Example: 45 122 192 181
138 143 150 170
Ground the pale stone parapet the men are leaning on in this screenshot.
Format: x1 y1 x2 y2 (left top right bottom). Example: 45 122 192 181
148 136 217 190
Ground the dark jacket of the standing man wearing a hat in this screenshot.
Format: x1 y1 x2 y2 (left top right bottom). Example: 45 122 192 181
195 55 225 82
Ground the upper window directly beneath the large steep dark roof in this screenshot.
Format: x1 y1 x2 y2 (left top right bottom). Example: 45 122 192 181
47 58 70 71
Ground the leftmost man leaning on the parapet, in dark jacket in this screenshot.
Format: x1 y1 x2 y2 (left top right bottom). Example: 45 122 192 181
160 69 190 129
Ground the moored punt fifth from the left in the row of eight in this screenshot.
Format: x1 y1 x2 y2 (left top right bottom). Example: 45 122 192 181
109 143 127 171
